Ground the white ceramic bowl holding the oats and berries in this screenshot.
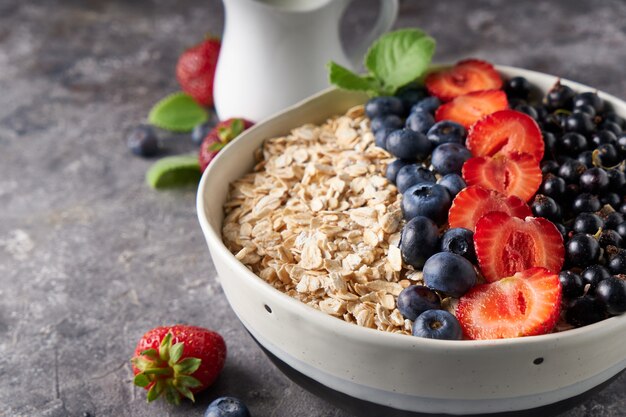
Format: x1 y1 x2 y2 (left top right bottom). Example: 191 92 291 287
197 67 626 414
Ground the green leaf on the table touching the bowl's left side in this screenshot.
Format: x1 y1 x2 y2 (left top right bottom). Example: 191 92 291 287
146 155 202 189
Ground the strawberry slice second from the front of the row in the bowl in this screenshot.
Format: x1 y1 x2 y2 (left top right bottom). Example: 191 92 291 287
474 212 565 282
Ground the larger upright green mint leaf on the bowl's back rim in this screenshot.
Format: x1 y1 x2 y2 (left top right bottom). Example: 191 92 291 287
365 29 435 94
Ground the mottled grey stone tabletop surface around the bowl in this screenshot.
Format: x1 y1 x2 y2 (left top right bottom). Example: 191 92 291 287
0 0 626 417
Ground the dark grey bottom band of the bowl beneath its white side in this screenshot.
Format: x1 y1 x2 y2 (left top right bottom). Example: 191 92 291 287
250 334 624 417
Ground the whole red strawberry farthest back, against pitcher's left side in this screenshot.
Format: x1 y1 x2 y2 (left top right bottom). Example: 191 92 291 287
176 38 220 106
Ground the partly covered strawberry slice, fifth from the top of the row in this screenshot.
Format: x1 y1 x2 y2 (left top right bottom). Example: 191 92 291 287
448 185 533 231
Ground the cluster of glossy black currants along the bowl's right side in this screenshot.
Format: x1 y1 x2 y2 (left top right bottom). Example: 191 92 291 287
505 77 626 327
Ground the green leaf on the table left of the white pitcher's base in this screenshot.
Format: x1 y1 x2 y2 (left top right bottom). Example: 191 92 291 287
148 93 209 132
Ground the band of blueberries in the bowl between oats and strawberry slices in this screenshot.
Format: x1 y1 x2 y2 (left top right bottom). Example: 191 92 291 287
365 86 476 340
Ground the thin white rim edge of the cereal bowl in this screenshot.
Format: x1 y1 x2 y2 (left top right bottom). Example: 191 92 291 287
196 65 626 351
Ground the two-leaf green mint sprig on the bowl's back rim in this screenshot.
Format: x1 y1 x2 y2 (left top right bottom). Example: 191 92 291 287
328 29 435 96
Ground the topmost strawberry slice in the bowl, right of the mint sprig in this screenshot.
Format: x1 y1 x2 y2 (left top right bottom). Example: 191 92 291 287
425 59 502 101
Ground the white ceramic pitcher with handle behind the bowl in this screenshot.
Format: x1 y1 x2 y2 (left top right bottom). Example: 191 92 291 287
213 0 398 122
